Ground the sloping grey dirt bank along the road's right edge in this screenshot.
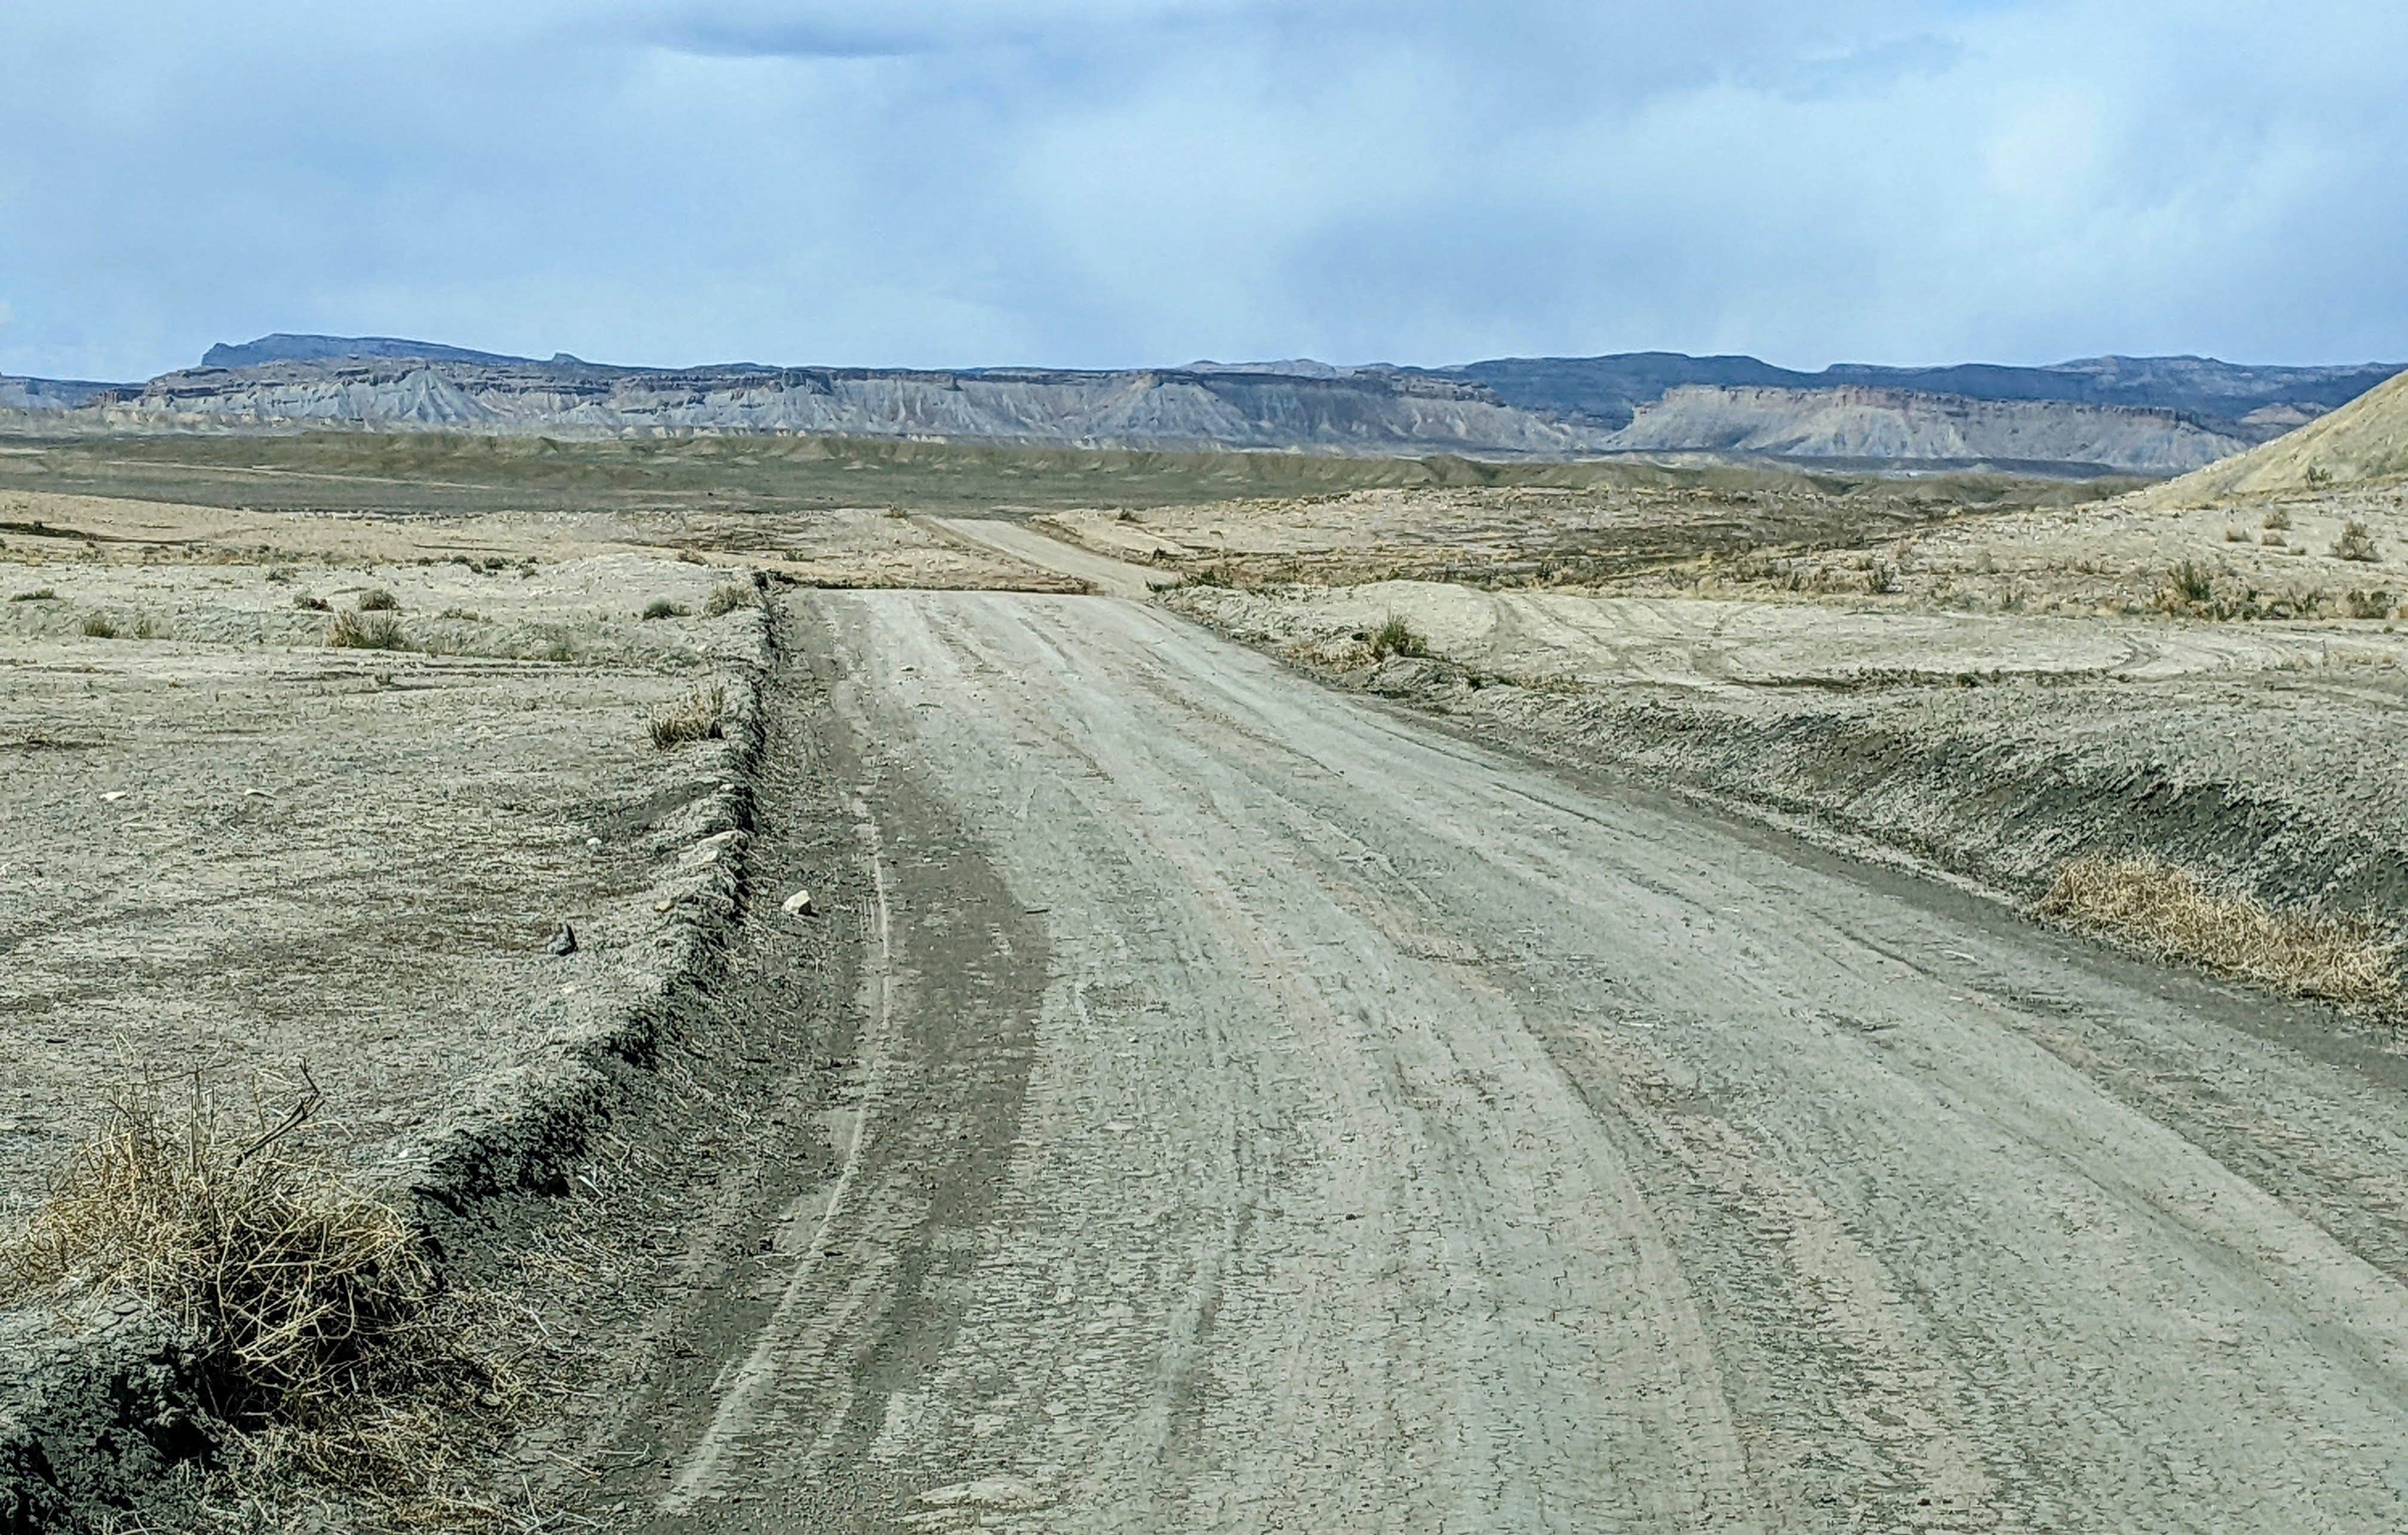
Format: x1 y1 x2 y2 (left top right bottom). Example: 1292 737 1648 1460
1163 588 2408 959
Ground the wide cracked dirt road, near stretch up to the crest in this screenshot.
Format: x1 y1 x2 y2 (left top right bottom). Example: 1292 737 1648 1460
597 592 2408 1533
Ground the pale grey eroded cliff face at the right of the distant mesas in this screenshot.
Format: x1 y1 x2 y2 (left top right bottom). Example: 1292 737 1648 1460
1613 386 2247 475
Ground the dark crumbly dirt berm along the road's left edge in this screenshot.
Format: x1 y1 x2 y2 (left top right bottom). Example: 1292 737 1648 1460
0 571 782 1535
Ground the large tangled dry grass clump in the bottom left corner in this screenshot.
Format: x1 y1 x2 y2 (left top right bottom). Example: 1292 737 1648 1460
0 1070 520 1506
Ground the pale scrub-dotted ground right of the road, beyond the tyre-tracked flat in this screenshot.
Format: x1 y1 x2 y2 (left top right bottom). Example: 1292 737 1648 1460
1038 484 2408 624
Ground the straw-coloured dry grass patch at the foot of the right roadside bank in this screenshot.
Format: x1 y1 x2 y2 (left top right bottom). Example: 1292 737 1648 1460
2035 853 2401 1007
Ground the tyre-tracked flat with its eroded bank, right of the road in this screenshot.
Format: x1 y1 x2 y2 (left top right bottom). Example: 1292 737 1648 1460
1165 583 2408 925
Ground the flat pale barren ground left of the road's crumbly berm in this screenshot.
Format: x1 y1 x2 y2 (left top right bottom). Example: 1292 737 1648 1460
0 542 749 1219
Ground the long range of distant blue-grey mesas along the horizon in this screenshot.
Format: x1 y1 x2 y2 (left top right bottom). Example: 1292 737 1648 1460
0 333 2398 477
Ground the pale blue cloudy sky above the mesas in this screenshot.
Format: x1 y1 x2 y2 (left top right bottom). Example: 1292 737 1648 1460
0 0 2408 378
